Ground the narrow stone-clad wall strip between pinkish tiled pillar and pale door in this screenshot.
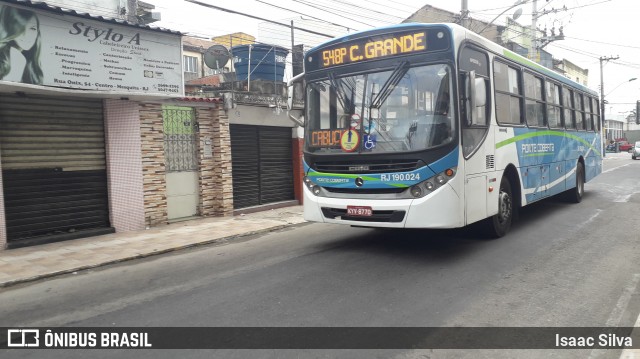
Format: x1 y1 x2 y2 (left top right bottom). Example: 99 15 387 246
140 103 168 226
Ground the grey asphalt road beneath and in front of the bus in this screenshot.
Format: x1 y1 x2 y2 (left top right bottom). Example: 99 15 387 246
0 154 640 358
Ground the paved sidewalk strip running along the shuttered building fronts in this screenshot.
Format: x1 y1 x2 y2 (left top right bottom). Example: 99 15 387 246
0 206 305 288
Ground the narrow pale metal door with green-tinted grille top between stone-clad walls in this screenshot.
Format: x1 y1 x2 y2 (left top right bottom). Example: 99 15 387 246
162 106 200 220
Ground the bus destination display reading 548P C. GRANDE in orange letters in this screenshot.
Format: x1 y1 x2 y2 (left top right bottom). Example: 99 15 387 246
305 28 449 71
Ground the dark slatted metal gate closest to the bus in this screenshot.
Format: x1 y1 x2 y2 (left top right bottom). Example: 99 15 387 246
230 125 294 209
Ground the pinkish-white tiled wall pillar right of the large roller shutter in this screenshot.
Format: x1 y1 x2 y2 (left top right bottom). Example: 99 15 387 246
104 100 145 232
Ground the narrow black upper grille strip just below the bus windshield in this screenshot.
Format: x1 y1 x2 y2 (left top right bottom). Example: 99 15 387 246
314 160 424 173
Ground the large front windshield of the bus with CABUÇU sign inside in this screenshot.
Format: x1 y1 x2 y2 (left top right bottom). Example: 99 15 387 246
305 62 456 154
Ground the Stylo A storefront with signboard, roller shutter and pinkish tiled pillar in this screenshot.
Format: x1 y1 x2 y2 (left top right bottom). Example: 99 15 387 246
0 1 184 250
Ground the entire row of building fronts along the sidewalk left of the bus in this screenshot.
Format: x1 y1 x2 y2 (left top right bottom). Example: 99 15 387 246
0 0 302 250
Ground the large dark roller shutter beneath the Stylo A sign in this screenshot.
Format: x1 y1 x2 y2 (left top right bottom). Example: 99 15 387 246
0 95 109 243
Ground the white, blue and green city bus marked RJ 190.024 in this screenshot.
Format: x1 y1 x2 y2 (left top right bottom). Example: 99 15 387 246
289 23 603 237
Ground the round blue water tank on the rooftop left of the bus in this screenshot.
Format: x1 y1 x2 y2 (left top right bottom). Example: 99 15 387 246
231 44 289 82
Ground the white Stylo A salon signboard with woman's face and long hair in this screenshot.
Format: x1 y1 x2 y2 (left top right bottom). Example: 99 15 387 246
0 2 184 96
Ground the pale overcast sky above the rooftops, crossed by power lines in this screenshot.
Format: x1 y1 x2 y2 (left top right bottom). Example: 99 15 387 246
146 0 640 115
